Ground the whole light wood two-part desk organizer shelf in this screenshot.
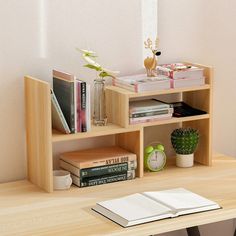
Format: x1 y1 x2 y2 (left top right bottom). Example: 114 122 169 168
25 62 212 192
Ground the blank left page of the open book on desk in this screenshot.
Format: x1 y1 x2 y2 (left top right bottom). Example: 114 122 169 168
97 193 171 221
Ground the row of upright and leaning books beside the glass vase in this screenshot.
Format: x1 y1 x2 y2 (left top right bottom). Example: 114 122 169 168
51 70 91 133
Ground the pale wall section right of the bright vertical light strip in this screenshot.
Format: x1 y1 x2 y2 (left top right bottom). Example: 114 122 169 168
158 0 236 157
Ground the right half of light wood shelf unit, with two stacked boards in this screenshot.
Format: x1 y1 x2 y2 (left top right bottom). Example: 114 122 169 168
106 63 213 165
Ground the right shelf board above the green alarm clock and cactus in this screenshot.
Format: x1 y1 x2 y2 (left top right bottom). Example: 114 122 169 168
129 114 210 127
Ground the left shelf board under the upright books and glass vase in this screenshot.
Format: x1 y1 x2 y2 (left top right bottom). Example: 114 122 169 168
52 124 140 143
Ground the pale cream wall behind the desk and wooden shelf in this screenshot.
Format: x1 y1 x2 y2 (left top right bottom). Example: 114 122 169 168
0 0 236 236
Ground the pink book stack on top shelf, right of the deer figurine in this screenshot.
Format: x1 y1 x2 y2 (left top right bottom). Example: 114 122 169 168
157 63 205 88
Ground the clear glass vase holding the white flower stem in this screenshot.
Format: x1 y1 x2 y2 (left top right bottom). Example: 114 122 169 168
93 77 107 126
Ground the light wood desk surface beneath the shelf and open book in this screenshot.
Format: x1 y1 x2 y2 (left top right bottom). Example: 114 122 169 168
0 156 236 236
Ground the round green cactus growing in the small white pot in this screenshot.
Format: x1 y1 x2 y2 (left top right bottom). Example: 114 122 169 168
171 128 199 155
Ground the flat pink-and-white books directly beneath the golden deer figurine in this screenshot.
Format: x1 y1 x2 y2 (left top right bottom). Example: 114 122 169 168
112 74 170 92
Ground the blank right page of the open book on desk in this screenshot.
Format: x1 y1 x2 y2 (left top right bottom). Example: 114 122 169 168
143 188 217 211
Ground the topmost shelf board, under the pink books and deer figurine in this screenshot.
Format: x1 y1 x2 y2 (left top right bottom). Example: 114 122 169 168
106 84 210 98
